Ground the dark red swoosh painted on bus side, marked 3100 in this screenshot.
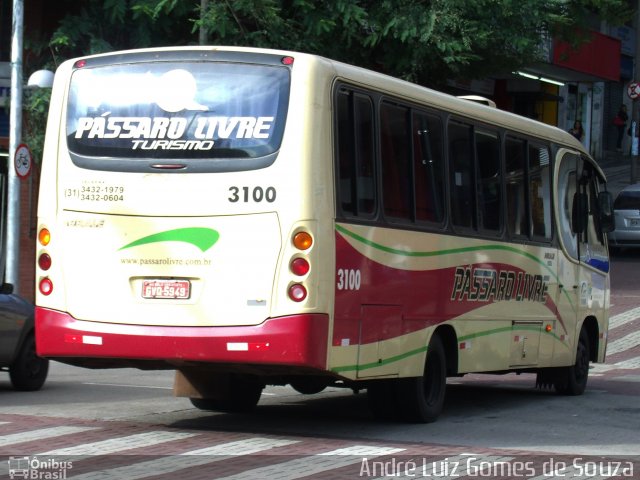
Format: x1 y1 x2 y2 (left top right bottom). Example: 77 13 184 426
332 233 566 346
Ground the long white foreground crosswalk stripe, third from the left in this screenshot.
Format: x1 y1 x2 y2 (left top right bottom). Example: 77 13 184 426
73 437 298 480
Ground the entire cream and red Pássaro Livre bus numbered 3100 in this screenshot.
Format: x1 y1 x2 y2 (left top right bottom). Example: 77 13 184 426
36 47 611 421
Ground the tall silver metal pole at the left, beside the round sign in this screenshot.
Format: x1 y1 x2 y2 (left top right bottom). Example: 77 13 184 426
5 0 24 293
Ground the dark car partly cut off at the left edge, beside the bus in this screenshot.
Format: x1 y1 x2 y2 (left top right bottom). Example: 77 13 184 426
0 284 49 391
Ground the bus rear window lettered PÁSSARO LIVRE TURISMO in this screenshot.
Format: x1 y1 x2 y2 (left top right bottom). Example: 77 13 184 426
66 62 289 170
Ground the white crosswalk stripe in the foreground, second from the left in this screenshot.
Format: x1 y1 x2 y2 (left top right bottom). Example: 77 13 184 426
38 431 197 455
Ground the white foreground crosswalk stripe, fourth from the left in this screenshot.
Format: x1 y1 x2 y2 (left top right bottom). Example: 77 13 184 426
218 445 404 480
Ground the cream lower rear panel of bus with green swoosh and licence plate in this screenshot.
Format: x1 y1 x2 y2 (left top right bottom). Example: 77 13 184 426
50 211 281 327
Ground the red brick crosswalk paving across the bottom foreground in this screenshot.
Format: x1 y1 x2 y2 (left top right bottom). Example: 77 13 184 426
0 414 640 480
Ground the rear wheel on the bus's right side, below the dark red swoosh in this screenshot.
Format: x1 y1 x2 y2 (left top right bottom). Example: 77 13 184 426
398 334 447 423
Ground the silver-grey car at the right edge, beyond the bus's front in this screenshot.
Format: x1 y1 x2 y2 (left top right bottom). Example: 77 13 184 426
609 183 640 249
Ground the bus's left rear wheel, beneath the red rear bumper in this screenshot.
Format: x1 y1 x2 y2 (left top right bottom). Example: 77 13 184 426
189 375 264 413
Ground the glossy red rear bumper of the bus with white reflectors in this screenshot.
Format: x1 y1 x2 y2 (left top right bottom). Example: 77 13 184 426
35 307 329 370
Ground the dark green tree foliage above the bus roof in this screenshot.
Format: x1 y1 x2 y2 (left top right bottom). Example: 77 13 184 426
26 0 631 158
